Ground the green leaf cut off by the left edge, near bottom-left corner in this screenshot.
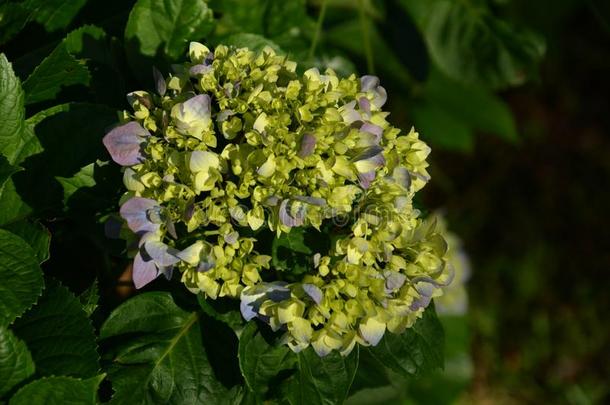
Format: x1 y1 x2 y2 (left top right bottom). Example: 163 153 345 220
0 326 34 398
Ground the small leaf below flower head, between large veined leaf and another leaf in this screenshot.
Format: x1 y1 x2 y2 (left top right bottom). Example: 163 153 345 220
239 321 296 397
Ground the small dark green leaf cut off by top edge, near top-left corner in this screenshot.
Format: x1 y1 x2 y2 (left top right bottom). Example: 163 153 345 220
23 0 87 31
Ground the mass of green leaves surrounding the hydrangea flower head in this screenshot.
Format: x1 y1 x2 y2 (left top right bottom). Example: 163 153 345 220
0 0 544 404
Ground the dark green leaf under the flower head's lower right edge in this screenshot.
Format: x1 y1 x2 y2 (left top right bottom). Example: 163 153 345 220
368 306 445 377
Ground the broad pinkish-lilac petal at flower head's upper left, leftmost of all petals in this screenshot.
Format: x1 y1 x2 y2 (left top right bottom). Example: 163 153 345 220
102 121 150 166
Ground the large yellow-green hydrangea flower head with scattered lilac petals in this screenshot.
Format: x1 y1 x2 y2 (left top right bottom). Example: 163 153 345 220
104 43 451 356
